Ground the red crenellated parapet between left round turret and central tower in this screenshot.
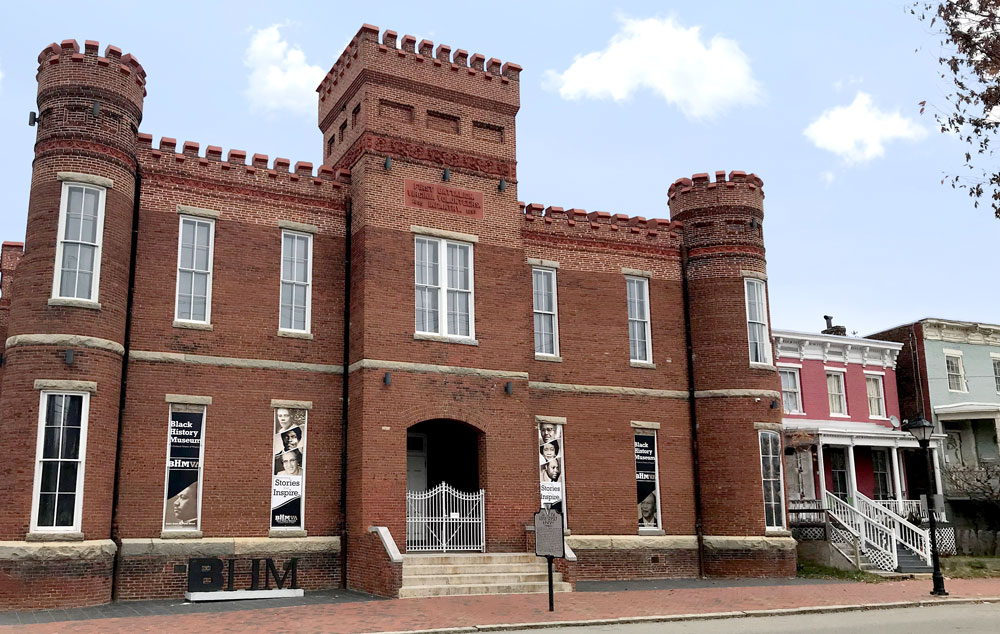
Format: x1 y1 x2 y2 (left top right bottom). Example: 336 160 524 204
138 132 351 193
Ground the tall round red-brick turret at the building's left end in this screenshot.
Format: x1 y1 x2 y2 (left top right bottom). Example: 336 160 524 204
0 40 146 601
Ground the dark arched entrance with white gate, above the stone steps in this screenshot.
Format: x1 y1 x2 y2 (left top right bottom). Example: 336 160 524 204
406 419 486 552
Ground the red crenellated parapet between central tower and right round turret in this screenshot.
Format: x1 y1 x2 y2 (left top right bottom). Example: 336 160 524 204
518 202 684 247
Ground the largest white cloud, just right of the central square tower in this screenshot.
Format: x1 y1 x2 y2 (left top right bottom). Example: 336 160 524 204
545 17 763 119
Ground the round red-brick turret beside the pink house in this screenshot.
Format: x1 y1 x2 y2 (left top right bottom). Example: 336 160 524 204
669 171 795 575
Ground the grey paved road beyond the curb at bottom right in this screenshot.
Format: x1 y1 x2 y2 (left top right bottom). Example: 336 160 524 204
506 604 1000 634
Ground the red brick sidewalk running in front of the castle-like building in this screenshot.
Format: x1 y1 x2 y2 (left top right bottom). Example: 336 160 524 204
0 579 1000 634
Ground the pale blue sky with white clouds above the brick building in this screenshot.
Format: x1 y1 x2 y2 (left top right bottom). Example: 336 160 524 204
0 0 1000 335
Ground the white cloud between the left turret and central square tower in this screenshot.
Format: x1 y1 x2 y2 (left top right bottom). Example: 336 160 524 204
243 24 326 112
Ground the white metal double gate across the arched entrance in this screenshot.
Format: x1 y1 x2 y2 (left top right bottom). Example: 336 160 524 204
406 482 486 552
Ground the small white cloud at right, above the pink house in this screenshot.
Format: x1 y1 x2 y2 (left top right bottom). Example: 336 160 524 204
803 90 927 163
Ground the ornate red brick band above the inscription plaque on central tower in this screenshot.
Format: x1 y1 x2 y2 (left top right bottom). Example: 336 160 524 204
336 131 517 179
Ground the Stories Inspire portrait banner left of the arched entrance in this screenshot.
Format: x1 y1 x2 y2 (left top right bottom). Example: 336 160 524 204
271 407 308 528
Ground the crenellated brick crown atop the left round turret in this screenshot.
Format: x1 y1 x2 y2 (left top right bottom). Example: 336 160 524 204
36 40 146 104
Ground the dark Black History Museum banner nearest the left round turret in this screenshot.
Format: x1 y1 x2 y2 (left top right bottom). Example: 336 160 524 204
163 405 205 530
